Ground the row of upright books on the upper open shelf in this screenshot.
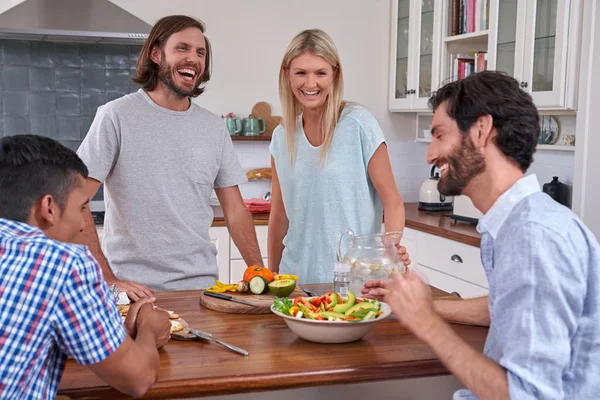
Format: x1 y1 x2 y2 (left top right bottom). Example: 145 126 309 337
450 0 490 36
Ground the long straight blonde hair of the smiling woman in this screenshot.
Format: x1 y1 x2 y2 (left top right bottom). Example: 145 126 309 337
279 29 344 165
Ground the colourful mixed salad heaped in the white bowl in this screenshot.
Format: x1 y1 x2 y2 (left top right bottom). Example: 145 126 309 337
273 290 383 322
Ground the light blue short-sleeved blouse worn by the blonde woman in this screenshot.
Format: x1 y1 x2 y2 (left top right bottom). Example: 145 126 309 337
269 105 385 283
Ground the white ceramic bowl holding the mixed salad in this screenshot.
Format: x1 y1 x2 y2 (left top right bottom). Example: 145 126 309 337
271 297 392 343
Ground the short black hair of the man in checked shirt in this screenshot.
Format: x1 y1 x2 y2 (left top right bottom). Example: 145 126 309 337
0 135 88 222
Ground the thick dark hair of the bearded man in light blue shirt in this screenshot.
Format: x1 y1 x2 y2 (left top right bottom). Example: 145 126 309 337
429 71 540 172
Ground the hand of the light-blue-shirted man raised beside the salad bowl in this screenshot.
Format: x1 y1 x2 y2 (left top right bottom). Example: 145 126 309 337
384 272 441 338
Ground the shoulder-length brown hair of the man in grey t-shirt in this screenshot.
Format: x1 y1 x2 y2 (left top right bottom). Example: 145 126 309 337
132 15 212 97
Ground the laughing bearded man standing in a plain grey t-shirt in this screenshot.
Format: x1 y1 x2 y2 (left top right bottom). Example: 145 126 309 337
78 15 262 300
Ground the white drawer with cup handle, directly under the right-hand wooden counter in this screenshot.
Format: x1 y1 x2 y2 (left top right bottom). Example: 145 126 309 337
417 231 489 288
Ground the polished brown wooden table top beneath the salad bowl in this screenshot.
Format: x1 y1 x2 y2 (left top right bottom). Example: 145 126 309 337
58 285 488 399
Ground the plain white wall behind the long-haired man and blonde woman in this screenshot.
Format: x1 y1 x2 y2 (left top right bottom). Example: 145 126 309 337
111 0 427 201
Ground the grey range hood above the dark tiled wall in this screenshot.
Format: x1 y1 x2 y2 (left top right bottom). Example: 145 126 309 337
0 0 152 45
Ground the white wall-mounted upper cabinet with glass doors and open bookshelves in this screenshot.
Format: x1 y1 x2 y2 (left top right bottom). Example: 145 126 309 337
389 0 583 111
